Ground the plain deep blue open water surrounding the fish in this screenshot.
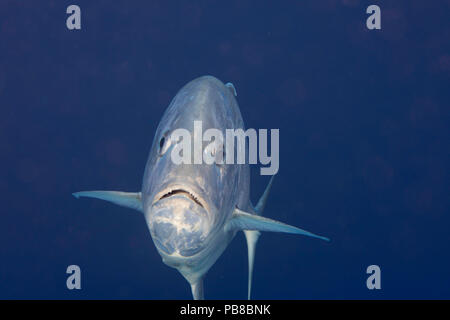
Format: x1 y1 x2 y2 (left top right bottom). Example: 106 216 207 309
0 0 450 299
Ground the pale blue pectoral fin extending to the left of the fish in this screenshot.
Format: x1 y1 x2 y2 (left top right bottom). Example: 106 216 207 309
72 191 143 212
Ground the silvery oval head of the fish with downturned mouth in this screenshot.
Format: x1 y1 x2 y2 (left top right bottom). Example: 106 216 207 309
142 77 243 266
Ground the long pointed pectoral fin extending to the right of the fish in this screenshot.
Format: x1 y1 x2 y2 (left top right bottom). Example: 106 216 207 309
226 208 330 241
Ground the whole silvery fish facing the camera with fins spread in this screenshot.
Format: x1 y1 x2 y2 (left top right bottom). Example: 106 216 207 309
73 75 329 300
